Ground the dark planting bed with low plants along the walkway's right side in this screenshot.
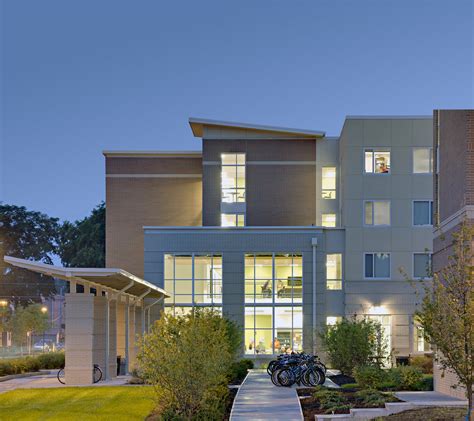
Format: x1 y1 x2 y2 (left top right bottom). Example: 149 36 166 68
297 388 401 421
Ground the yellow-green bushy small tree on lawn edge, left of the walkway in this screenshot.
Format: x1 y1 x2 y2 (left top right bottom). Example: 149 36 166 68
138 309 235 420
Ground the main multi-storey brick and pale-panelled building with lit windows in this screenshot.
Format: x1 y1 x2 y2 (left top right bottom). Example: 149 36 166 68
104 116 433 357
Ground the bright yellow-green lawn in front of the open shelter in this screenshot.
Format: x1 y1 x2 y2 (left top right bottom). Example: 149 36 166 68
0 386 154 421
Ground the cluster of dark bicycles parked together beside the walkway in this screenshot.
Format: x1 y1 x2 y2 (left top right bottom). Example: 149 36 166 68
267 353 326 387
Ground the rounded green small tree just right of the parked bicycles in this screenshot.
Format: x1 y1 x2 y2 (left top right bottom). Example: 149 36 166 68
319 316 387 375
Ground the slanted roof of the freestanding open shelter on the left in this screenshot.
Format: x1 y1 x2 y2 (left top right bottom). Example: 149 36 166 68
3 256 169 298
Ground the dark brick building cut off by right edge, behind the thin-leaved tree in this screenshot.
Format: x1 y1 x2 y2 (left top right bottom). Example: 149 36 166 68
433 110 474 398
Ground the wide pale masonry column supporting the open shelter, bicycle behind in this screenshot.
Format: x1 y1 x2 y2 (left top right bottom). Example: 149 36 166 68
64 293 94 386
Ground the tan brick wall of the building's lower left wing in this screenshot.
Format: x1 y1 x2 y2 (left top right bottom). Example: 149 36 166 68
106 157 202 276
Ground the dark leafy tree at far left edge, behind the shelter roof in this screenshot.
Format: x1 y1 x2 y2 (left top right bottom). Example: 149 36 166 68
0 204 58 302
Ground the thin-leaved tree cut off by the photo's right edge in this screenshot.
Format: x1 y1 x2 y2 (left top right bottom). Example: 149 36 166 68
417 221 474 420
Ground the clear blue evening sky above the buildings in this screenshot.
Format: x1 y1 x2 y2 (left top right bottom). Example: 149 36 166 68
0 0 474 220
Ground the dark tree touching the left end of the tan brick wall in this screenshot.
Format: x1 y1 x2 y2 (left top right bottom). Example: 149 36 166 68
58 202 105 267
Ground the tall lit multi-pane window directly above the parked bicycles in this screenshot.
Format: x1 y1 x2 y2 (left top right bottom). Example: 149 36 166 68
245 253 303 354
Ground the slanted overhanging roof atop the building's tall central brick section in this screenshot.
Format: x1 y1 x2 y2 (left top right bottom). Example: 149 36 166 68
189 117 326 138
